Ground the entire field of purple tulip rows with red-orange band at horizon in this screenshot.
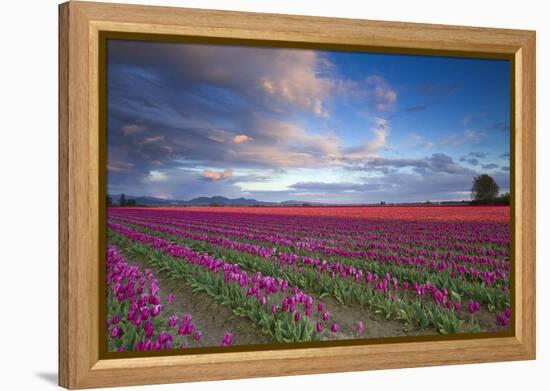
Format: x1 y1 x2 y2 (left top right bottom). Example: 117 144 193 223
106 206 511 351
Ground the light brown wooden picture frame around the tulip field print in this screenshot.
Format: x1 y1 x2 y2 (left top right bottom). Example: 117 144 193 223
59 1 535 389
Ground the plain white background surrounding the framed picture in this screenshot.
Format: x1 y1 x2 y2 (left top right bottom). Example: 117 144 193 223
0 0 550 391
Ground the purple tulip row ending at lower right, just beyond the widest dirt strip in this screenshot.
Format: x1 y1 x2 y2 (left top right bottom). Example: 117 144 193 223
109 219 492 333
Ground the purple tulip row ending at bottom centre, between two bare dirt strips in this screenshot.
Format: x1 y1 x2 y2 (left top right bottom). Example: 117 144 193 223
108 223 350 342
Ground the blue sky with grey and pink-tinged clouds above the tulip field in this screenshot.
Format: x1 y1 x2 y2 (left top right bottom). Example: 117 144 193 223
107 40 510 204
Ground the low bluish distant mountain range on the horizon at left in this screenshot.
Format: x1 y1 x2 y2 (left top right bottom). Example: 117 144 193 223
109 195 322 206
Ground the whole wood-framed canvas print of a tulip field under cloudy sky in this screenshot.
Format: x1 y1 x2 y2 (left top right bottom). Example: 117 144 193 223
59 2 535 388
